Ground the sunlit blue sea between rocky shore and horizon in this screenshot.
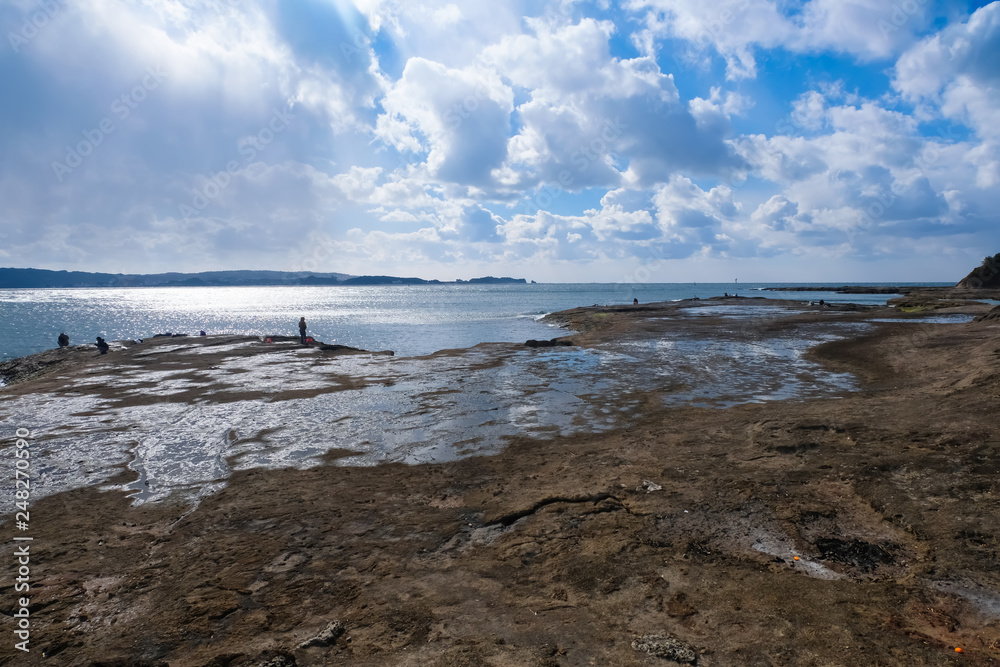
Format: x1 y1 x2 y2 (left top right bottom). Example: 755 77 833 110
0 283 951 359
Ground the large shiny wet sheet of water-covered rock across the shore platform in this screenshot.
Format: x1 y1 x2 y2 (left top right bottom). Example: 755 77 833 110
0 310 876 504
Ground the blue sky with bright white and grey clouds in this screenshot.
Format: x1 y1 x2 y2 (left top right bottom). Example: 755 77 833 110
0 0 1000 282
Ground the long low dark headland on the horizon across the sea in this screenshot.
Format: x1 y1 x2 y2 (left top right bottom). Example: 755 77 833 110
0 268 534 289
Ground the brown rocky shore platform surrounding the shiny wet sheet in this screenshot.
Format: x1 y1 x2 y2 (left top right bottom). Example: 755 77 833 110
0 299 1000 667
